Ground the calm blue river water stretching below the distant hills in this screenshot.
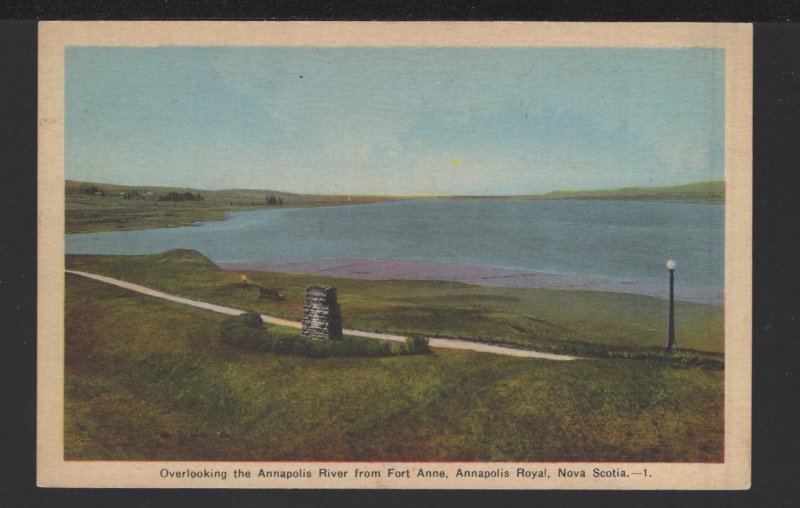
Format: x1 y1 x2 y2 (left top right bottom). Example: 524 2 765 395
66 199 724 290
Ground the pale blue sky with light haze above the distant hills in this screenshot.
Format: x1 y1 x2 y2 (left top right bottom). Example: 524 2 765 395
65 47 724 195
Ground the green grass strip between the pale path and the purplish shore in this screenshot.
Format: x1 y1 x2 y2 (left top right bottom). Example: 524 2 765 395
67 250 724 363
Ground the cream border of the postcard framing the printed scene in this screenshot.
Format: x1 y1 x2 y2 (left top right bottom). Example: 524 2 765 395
37 21 752 490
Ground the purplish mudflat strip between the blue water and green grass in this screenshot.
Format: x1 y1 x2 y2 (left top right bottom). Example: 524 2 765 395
217 258 724 307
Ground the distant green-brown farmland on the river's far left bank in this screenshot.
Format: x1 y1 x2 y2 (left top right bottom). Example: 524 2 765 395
65 180 406 233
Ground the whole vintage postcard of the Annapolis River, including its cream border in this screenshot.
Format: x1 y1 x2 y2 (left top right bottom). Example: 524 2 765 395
37 22 752 490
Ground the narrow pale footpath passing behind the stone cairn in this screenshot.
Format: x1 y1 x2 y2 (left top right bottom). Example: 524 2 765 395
66 270 576 360
